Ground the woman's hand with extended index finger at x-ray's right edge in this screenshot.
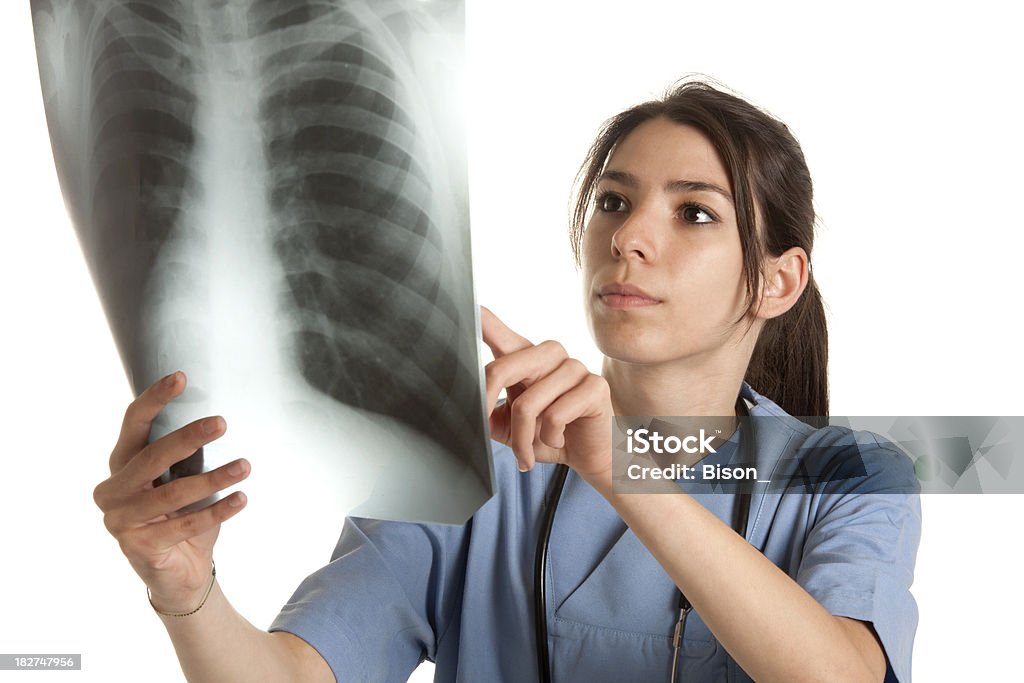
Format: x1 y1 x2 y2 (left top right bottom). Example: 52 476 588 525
480 306 612 479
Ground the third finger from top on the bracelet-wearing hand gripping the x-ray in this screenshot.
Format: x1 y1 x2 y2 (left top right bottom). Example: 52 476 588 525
103 460 251 536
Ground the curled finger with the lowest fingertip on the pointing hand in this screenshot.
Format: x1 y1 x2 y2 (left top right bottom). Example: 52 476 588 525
508 358 590 472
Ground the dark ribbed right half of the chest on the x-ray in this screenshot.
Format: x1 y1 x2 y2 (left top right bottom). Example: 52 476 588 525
250 0 478 481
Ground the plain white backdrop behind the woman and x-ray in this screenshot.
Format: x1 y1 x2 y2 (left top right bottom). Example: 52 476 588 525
0 0 1024 681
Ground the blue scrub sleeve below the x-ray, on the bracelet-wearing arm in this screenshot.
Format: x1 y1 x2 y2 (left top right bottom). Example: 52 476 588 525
269 517 472 683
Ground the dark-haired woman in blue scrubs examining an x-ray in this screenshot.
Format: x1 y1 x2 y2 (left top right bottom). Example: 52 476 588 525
95 82 920 682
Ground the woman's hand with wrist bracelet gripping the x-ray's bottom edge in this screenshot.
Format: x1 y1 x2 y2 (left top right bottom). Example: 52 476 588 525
93 372 250 612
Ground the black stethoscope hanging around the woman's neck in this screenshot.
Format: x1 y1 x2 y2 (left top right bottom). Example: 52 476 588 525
534 399 753 683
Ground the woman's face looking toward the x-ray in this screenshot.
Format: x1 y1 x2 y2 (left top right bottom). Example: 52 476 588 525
583 118 746 365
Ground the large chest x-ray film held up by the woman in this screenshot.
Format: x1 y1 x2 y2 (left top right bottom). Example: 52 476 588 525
32 0 492 522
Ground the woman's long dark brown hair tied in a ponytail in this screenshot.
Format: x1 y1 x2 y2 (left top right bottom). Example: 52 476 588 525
570 80 828 417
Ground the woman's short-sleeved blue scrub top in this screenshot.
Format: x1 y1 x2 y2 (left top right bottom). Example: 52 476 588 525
270 384 921 683
